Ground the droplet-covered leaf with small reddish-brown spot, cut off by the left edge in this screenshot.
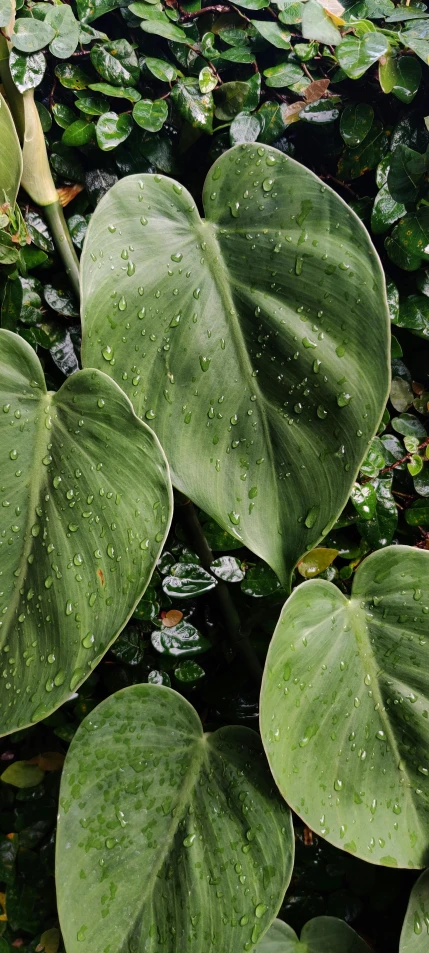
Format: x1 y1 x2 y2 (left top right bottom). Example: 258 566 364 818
0 330 171 734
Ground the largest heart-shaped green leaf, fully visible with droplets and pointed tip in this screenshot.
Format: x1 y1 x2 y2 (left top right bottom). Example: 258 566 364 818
82 145 389 583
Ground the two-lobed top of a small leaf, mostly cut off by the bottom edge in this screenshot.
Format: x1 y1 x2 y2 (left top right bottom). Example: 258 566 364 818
254 917 369 953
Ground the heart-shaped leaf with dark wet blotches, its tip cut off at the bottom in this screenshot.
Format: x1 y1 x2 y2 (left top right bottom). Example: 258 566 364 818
57 684 294 953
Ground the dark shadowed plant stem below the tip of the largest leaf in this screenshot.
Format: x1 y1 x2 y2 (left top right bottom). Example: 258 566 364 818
176 493 262 685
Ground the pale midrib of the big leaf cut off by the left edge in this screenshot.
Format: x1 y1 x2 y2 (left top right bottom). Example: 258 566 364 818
2 392 52 644
